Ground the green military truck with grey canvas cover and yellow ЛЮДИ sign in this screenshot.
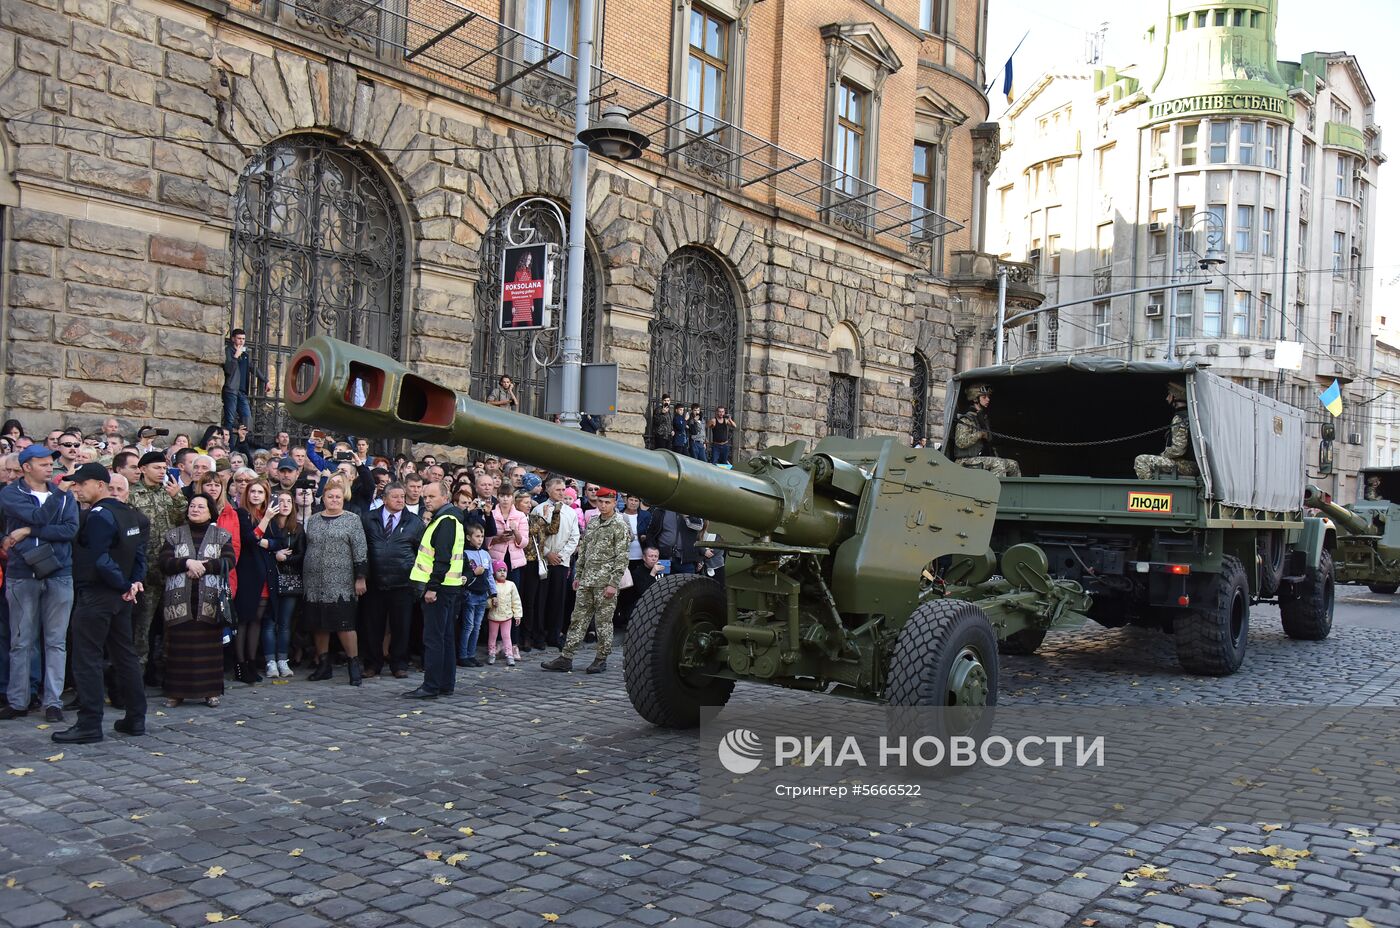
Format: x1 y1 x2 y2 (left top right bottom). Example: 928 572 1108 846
944 357 1337 675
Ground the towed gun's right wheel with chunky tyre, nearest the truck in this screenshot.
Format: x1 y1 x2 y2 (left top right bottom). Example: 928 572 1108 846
885 599 997 736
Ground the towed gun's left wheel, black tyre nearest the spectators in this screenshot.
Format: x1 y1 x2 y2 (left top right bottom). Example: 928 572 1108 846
623 574 734 728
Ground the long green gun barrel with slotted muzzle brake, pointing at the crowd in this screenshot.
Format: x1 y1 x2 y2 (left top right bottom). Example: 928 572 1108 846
284 336 854 544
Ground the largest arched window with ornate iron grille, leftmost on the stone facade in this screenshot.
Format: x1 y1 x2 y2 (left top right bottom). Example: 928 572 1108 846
232 136 405 440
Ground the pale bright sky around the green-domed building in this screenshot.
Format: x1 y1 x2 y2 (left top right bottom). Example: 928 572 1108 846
987 0 1400 334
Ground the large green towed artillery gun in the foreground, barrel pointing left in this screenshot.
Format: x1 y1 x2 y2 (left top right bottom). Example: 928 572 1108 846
286 337 1089 728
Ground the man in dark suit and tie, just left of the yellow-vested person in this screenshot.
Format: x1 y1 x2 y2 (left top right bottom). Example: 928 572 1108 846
358 483 427 679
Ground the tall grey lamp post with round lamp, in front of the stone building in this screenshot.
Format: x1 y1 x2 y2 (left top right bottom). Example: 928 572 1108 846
559 0 648 426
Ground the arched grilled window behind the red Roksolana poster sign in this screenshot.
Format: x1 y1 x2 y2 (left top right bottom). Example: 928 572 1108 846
470 200 599 416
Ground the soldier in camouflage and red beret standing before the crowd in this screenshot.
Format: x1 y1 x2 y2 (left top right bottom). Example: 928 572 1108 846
540 487 631 673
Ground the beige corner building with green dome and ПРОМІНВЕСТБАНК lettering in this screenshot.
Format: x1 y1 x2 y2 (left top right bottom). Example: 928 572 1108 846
987 0 1386 497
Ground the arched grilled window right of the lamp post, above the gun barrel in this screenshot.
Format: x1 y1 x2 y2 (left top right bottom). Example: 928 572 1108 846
650 248 739 417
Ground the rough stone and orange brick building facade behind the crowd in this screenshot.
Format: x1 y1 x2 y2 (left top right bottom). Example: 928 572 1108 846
0 0 995 449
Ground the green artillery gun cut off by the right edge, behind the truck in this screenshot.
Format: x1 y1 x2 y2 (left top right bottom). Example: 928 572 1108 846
1303 467 1400 596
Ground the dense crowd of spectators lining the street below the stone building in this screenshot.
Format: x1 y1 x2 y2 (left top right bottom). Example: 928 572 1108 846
0 414 735 722
